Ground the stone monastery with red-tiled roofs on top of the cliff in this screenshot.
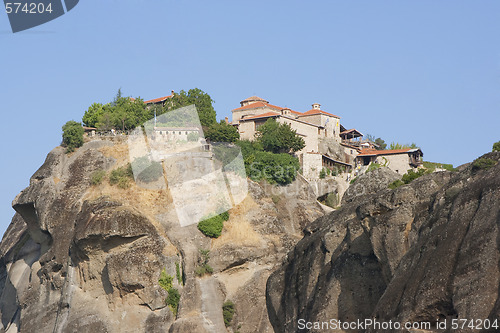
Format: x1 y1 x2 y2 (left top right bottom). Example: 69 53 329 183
230 96 423 179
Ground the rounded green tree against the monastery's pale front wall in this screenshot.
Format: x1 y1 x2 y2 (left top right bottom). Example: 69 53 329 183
256 118 305 154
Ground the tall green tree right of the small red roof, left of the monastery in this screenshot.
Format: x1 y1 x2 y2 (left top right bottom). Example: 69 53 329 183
163 88 217 127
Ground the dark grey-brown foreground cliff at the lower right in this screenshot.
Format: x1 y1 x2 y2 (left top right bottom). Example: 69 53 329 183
266 153 500 332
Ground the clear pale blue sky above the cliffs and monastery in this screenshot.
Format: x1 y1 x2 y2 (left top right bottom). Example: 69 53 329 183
0 0 500 233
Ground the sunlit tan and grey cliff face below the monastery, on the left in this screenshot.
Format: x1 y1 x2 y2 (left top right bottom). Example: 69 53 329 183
0 140 323 333
